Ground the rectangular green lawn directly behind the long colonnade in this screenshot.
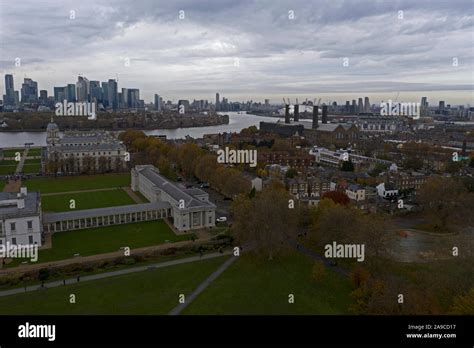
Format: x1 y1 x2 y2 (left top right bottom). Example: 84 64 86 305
41 189 135 212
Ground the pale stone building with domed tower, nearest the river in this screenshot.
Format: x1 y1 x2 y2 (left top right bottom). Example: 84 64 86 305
45 118 129 173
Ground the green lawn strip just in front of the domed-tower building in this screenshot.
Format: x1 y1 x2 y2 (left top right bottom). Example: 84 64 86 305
25 173 130 193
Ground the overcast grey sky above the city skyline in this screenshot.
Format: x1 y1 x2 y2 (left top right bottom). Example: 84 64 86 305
0 0 474 105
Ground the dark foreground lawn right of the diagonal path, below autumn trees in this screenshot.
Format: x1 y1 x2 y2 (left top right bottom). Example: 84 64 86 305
183 253 352 315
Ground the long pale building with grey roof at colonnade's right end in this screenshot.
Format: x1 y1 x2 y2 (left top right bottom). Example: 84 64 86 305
132 165 216 231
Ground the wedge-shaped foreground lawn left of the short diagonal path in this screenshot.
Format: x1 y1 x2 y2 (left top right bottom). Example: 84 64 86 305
0 257 225 315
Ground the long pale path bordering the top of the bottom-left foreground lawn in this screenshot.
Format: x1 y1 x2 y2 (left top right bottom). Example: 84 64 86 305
0 250 231 297
